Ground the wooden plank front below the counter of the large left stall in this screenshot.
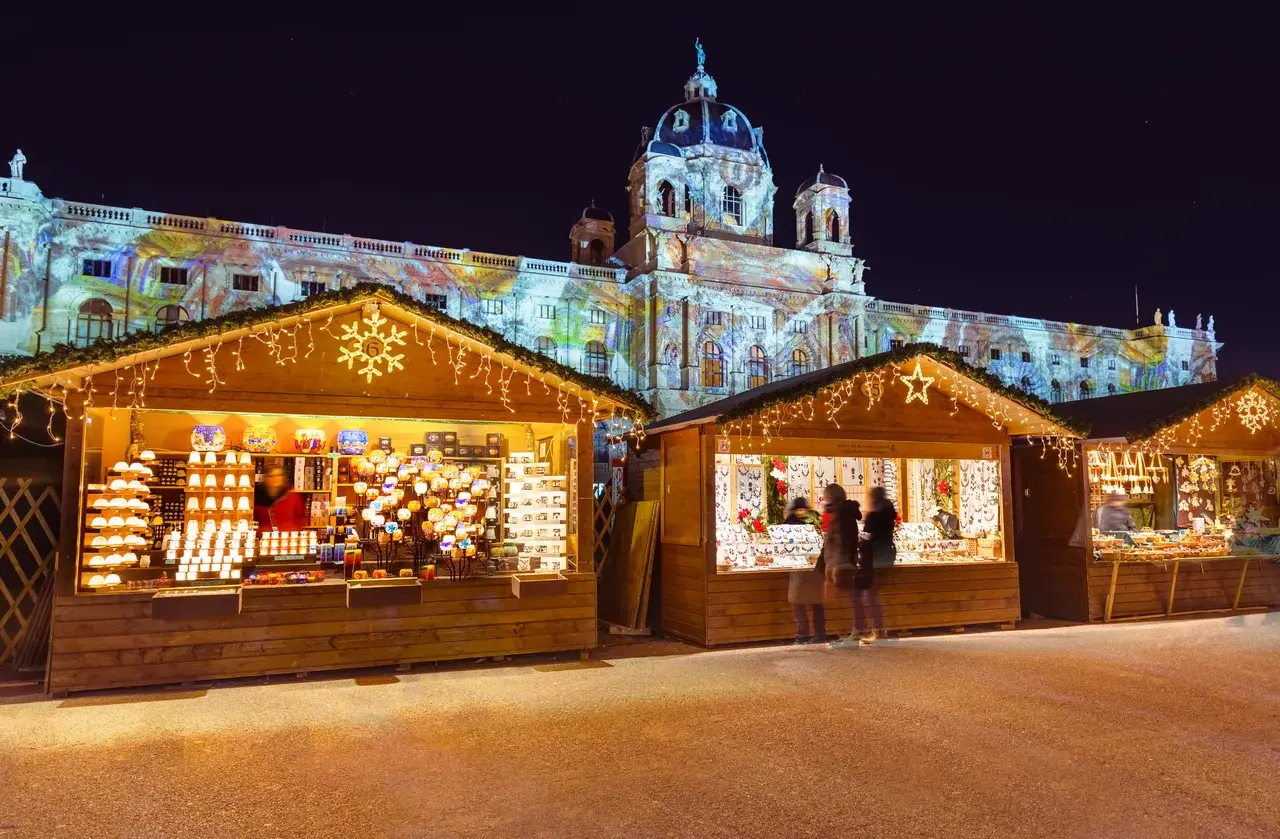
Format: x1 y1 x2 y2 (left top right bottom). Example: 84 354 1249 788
49 574 596 693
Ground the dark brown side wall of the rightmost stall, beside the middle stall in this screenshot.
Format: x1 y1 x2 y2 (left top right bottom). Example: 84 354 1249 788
1012 447 1089 621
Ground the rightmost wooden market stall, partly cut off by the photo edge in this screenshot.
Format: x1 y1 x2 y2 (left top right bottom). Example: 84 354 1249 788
1015 377 1280 621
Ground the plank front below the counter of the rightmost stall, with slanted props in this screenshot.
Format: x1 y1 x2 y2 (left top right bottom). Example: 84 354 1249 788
1089 560 1280 620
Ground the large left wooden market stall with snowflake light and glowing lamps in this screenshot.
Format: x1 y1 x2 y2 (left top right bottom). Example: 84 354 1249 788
0 284 648 693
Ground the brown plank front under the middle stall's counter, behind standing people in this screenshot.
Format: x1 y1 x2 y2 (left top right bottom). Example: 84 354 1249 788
705 562 1021 646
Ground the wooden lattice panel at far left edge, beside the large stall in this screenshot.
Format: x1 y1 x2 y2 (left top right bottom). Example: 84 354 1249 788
0 478 61 664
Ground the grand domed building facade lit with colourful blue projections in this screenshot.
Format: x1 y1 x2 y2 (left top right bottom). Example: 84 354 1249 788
0 49 1221 415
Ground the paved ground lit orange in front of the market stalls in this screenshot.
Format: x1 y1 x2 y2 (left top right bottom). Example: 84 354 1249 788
0 614 1280 839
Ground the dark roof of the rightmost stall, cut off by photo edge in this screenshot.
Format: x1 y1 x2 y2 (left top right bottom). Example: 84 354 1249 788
1053 374 1280 442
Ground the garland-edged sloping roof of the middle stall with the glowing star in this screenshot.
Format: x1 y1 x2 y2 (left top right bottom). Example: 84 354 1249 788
646 343 1088 437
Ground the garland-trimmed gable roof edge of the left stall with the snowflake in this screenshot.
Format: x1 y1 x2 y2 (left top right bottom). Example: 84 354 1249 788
0 283 653 419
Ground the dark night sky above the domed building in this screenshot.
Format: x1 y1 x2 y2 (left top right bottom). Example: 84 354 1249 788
0 3 1280 377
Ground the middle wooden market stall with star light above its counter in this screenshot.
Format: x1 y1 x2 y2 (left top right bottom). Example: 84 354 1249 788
637 345 1078 646
